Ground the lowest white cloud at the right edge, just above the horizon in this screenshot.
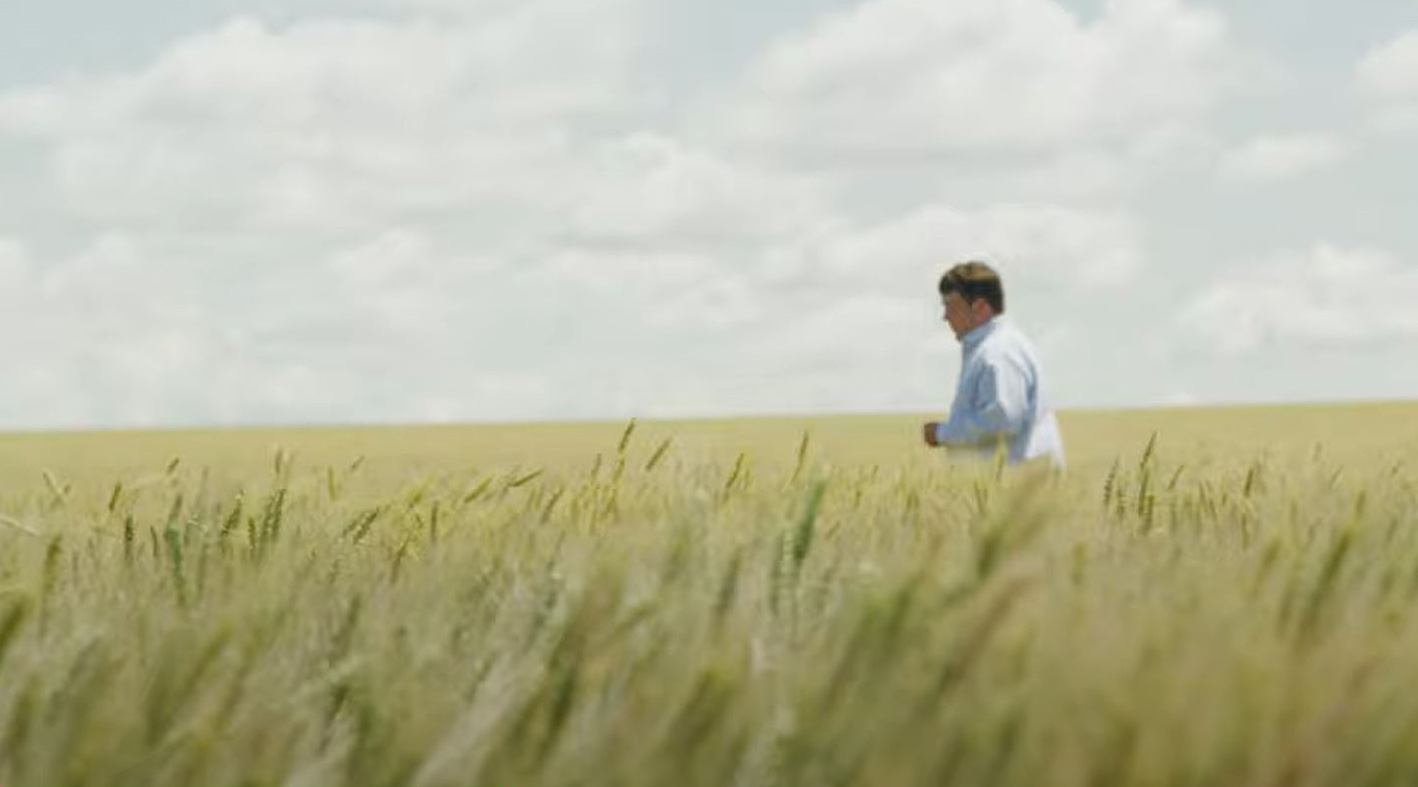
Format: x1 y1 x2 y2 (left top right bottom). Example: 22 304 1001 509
1177 245 1418 356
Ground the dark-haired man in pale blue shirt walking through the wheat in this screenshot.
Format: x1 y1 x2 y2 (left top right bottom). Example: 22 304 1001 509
925 262 1064 468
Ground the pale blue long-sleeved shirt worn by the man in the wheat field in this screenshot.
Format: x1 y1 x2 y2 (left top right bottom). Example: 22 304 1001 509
936 316 1064 468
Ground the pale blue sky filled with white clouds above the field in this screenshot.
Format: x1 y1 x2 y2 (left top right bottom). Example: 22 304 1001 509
0 0 1418 430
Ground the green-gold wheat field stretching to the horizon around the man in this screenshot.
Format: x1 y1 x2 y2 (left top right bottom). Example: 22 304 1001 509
0 404 1418 787
